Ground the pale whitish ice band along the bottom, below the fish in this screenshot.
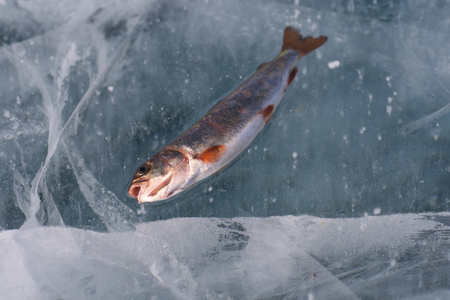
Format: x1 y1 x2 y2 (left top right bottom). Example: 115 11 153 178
0 213 450 299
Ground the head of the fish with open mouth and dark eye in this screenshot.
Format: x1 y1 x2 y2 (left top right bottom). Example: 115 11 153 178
128 149 190 203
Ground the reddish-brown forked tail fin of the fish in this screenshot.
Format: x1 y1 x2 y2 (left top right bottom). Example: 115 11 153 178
281 26 328 57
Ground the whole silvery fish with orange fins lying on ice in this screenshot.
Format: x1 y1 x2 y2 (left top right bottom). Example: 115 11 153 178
128 26 328 203
